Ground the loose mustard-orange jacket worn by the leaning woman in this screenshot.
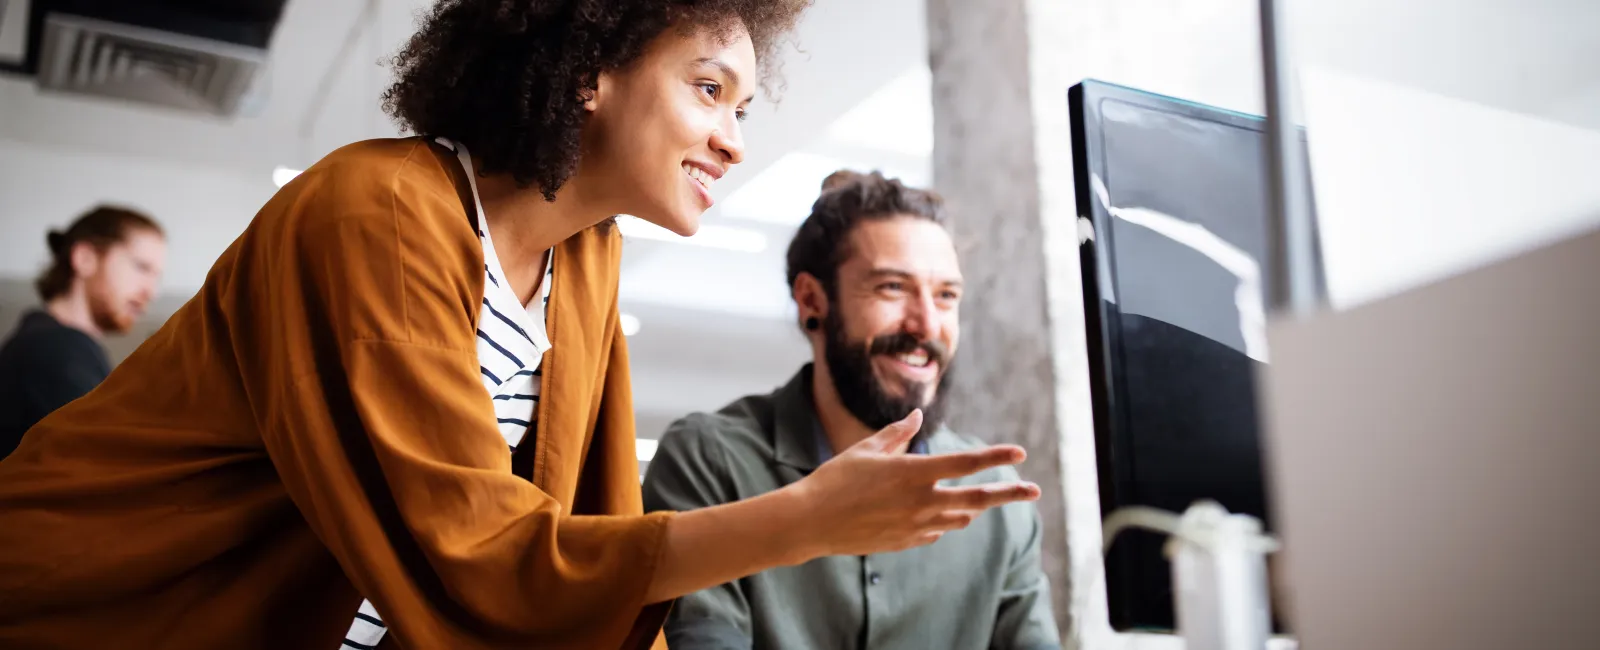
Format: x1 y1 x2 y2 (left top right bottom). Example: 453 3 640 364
0 138 672 650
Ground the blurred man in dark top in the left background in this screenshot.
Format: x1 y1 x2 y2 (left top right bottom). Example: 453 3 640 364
0 207 166 458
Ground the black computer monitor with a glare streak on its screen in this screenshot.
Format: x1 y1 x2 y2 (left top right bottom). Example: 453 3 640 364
1069 80 1305 631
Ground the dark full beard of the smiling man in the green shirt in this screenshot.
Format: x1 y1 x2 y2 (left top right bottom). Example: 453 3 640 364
822 311 950 443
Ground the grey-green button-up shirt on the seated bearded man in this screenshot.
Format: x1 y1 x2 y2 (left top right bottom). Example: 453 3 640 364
645 365 1061 650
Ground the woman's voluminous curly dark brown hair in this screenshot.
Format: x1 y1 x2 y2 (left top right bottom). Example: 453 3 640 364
384 0 811 200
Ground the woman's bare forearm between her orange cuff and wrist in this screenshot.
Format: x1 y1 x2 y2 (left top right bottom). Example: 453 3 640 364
645 485 824 602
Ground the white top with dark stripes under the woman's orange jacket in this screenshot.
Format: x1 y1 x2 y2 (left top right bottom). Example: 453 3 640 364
344 139 555 650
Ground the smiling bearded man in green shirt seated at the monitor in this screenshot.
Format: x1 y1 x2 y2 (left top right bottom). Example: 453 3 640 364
645 171 1061 650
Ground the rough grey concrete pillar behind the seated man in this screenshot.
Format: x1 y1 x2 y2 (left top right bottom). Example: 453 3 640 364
928 0 1093 634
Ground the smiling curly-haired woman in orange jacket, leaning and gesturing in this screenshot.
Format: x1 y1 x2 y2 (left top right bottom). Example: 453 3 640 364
0 0 1037 650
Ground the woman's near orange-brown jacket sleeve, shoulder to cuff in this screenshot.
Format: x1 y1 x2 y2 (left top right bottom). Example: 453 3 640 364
248 167 670 648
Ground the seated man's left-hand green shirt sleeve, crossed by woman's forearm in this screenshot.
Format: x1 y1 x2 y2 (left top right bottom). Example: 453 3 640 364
643 415 752 650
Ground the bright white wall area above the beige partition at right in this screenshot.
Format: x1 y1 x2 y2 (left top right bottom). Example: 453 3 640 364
1301 69 1600 309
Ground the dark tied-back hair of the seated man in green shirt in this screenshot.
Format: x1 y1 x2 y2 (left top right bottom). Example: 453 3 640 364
787 170 946 299
